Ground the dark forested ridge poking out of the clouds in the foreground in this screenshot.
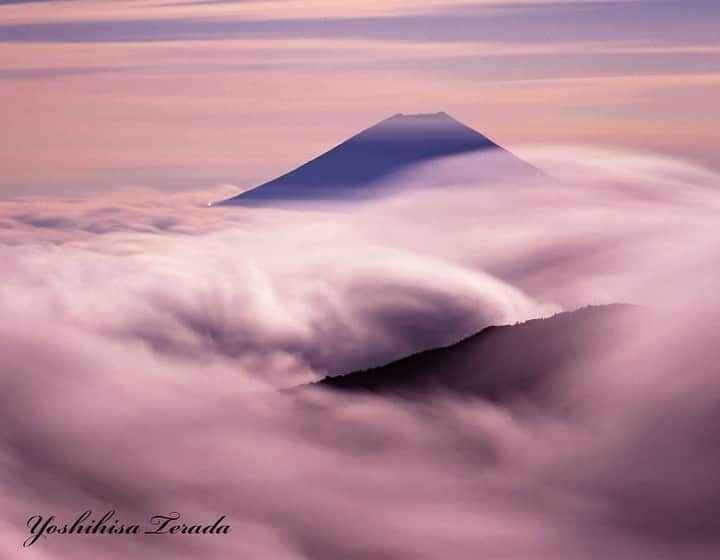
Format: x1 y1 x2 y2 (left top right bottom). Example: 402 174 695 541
310 304 641 402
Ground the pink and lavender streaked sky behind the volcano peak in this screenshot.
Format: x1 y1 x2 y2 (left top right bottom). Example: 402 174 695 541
0 0 720 198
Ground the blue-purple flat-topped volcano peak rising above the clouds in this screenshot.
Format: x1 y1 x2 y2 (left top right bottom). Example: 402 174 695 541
217 113 532 206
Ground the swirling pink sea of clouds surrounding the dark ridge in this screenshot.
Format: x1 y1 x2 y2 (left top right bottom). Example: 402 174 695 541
0 148 720 560
